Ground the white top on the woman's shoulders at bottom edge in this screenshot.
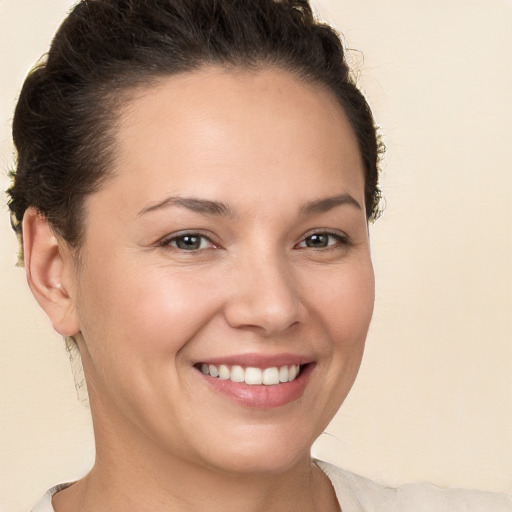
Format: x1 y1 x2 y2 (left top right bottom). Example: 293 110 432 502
32 460 512 512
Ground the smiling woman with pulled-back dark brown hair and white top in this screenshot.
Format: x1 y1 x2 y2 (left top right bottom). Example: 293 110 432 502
10 0 512 512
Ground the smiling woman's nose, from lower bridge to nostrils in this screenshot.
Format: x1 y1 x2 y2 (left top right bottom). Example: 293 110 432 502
224 251 302 337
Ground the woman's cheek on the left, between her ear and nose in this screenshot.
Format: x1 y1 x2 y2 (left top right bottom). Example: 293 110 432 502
78 264 220 358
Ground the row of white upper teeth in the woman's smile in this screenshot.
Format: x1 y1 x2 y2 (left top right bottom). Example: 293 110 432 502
201 364 300 386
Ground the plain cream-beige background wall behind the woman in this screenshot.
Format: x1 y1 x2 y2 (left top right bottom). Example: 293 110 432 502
0 0 512 512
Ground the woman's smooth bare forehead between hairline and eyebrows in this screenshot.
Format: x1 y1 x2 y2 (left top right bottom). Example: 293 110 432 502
94 68 364 216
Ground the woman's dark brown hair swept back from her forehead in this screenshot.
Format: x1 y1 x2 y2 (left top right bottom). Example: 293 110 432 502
8 0 382 256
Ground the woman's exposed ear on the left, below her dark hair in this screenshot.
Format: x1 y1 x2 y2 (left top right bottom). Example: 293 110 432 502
23 208 80 336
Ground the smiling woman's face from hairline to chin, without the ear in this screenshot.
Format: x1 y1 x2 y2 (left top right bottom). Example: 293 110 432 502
70 68 374 472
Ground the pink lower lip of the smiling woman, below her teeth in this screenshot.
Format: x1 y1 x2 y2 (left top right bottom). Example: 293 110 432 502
198 363 314 409
